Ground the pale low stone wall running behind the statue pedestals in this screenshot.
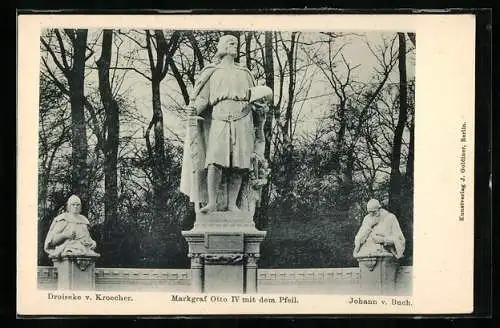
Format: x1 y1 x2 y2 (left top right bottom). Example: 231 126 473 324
38 266 412 295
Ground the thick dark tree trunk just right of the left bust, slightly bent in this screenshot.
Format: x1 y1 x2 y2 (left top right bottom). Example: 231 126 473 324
97 30 119 232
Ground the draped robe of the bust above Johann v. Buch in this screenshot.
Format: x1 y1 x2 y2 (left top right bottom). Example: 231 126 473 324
353 209 405 259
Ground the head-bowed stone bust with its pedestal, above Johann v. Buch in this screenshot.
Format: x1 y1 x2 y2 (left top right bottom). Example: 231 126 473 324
353 199 405 294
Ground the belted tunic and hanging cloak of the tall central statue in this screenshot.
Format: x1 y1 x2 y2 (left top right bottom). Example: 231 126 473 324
180 64 255 207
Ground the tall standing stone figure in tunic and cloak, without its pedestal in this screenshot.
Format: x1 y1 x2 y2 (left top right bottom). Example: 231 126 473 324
180 35 272 214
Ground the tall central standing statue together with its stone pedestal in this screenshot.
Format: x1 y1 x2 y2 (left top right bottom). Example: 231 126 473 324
180 35 273 293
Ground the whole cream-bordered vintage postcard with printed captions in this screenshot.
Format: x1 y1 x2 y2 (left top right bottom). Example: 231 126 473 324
17 14 475 315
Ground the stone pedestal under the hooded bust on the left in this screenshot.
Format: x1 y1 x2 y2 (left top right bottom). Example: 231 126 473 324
52 256 97 290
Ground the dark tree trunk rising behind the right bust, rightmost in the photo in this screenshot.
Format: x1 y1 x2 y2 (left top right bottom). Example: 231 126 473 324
389 33 408 216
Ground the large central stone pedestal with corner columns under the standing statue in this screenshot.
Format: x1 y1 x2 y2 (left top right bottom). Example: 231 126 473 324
182 212 266 293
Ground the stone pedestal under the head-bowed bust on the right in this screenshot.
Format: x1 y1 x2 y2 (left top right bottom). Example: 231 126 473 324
358 256 399 295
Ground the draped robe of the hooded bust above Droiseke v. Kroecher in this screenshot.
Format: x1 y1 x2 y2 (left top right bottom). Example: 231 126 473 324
44 213 97 258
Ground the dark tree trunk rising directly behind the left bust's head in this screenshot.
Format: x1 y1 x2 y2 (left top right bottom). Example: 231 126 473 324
68 30 88 200
